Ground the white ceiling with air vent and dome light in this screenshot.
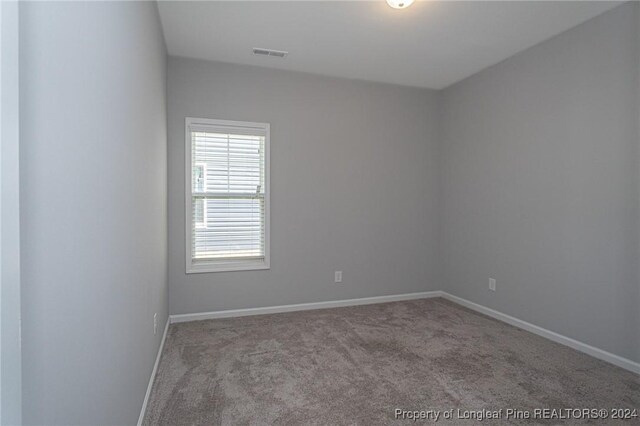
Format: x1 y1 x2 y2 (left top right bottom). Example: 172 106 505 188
159 0 621 89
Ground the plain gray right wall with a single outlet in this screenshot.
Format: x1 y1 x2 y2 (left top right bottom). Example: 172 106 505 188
440 3 640 361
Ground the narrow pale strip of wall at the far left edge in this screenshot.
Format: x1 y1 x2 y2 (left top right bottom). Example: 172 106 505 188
0 1 22 425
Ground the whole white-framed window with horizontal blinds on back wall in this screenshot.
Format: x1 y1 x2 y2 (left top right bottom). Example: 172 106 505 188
185 118 269 273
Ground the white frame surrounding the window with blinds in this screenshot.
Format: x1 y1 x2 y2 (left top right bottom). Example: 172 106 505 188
184 117 271 274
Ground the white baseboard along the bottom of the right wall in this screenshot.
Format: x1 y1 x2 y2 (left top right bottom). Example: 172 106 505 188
441 291 640 374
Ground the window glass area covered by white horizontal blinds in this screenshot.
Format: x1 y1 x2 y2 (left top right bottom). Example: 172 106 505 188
191 128 265 261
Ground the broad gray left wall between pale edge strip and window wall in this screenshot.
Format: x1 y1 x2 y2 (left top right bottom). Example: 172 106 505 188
20 2 168 425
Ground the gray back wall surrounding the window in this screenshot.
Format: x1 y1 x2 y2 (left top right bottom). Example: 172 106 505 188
168 58 440 314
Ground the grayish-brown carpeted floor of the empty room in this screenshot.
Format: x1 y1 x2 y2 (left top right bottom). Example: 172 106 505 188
144 299 640 425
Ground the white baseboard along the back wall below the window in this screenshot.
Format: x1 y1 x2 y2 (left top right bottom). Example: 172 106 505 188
169 291 442 323
